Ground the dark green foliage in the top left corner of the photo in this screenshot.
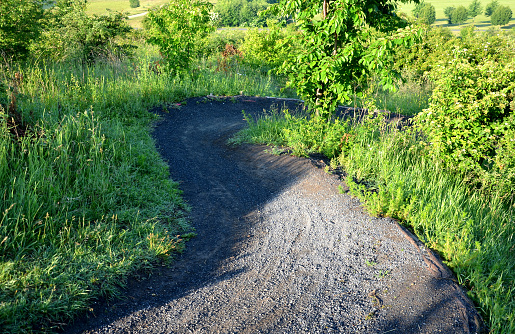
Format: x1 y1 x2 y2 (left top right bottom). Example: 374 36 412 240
0 0 44 58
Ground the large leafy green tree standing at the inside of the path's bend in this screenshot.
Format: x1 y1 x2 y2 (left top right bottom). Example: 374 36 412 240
270 0 422 114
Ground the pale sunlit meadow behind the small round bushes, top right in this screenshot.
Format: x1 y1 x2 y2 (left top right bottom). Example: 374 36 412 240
398 0 515 30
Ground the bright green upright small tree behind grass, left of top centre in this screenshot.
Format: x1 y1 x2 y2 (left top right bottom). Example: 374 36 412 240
144 0 215 72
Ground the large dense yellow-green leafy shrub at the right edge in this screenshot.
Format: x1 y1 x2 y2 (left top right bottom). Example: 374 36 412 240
415 37 515 192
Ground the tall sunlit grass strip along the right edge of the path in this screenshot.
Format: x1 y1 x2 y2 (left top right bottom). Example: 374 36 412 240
235 103 515 333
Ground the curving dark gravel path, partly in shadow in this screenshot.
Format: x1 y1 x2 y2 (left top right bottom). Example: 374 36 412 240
66 97 480 333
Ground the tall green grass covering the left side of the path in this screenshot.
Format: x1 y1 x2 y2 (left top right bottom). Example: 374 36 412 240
0 45 294 333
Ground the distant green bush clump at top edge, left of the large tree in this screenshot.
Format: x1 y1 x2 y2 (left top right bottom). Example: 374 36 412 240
214 0 270 27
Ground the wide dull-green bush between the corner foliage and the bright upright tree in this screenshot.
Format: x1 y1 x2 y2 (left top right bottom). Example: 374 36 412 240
32 0 132 61
